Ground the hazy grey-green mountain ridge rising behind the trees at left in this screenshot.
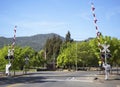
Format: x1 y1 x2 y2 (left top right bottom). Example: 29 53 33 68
0 33 64 51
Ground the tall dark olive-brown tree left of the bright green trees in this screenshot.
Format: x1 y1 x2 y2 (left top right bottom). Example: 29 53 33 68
45 35 62 69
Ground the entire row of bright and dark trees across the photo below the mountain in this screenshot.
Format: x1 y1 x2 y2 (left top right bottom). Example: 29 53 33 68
0 32 120 70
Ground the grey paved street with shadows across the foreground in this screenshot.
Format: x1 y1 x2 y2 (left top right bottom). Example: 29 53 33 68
0 71 120 87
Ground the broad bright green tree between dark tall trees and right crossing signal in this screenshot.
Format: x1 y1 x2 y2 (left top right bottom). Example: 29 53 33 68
57 42 98 68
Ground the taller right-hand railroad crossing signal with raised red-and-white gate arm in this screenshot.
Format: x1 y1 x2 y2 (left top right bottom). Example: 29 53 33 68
91 3 111 79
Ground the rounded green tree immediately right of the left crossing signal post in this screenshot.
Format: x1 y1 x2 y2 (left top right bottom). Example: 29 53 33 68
11 46 34 75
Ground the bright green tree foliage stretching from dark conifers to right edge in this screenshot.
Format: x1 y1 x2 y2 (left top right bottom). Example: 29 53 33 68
57 36 120 68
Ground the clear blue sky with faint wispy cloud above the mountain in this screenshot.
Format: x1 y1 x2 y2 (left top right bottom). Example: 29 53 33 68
0 0 120 40
